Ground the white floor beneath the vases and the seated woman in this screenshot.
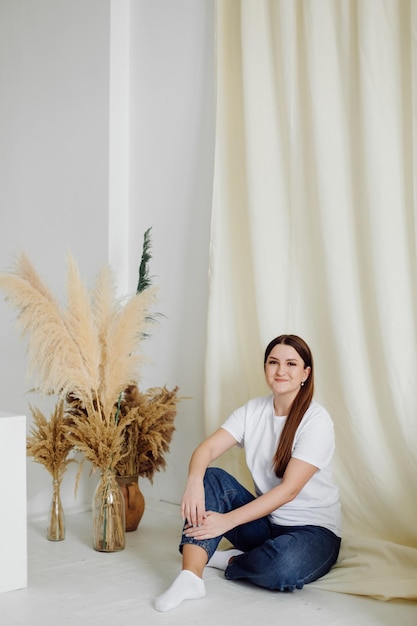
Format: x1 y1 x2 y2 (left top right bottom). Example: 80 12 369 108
0 502 417 626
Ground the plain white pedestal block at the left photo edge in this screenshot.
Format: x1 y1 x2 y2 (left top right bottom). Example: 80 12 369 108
0 411 27 593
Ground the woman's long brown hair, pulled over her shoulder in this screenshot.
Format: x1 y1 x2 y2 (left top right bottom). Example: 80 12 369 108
264 335 314 478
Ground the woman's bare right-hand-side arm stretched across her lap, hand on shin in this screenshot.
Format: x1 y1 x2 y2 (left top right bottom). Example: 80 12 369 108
187 458 317 539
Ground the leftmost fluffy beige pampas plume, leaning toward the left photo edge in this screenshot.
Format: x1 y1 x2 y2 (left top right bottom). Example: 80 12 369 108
0 266 93 395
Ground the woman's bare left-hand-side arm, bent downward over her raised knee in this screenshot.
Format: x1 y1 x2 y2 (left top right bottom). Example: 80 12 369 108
181 428 236 526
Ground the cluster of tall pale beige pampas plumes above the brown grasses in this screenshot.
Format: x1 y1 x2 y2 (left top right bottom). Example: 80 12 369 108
0 253 155 408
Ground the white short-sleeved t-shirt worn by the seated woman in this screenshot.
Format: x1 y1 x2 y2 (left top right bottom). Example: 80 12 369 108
222 395 341 537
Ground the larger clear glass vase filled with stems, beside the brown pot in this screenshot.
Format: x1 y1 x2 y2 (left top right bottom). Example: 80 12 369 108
92 470 125 552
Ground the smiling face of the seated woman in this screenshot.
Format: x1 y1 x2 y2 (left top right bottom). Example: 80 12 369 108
265 343 311 402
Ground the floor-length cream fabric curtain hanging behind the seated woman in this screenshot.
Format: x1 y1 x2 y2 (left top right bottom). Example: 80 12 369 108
206 0 417 599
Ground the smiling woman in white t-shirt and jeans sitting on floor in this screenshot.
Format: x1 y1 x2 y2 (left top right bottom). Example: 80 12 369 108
155 335 341 611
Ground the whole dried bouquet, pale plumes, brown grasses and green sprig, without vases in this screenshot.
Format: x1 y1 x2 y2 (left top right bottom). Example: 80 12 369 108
0 234 180 498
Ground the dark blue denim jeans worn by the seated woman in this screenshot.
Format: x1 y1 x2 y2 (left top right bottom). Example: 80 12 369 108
180 468 341 591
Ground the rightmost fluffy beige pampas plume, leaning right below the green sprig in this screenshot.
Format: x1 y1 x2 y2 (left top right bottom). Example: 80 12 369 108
100 288 156 414
